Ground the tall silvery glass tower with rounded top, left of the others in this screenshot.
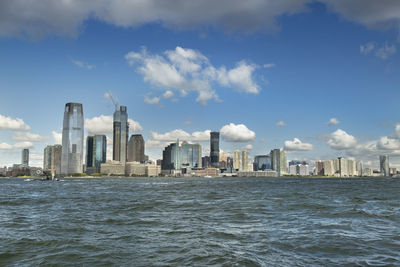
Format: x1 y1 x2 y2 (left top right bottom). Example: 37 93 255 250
61 103 84 174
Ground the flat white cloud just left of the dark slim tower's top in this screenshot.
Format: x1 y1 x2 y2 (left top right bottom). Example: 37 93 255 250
150 129 211 142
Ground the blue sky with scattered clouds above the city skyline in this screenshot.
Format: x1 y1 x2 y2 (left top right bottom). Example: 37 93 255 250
0 0 400 168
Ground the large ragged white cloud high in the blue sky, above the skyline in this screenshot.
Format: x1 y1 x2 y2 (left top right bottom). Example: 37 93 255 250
125 46 260 105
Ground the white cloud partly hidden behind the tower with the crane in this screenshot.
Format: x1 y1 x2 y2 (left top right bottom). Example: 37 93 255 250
85 115 143 134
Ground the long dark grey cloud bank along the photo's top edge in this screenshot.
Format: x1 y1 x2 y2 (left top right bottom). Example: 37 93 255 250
0 0 400 38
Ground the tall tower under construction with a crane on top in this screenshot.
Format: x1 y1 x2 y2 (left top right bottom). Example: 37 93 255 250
113 106 129 163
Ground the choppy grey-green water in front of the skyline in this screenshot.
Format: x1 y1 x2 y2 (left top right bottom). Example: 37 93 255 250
0 178 400 266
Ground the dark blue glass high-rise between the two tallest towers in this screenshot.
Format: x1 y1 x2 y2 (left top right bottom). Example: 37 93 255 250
86 135 107 173
